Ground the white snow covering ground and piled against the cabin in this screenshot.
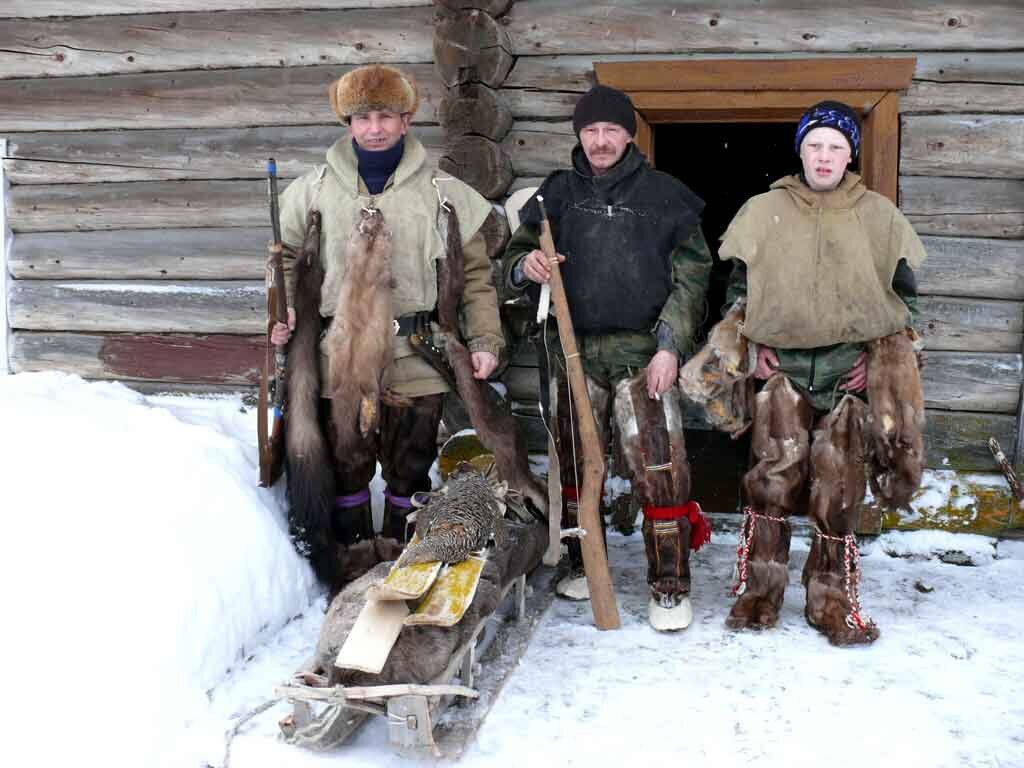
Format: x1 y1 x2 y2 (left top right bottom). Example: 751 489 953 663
0 374 1024 768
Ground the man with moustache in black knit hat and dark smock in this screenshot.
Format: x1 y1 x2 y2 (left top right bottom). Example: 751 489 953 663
506 85 712 630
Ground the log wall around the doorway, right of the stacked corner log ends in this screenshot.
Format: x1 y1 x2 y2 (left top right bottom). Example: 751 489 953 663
435 0 1024 469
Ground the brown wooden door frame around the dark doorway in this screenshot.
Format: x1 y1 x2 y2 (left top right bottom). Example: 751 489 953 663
594 57 918 203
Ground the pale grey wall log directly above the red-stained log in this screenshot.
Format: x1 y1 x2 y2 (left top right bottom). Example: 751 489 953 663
8 280 266 334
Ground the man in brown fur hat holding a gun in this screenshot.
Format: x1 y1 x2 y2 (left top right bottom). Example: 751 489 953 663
272 65 504 580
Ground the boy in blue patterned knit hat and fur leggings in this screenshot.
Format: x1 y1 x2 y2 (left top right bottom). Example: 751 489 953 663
719 101 925 645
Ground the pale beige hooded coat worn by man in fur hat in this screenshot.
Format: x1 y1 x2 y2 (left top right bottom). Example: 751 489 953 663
281 134 505 397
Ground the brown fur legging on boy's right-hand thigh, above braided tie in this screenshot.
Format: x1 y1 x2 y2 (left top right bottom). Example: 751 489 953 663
808 394 866 536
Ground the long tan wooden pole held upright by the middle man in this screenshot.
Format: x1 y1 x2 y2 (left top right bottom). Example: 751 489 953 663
537 197 620 630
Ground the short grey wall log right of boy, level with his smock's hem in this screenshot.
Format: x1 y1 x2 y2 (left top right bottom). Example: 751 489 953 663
916 296 1024 352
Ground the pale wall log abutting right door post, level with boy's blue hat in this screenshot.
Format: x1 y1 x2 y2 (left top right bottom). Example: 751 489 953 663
899 115 1024 178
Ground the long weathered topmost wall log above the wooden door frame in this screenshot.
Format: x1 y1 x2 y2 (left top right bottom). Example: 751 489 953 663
507 0 1024 55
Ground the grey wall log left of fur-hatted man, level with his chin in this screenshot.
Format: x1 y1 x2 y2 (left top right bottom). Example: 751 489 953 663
4 128 444 184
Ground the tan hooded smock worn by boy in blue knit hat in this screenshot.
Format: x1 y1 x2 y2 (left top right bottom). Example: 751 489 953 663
719 171 925 349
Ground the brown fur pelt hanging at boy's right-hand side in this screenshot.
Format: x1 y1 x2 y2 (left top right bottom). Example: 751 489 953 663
867 332 925 508
